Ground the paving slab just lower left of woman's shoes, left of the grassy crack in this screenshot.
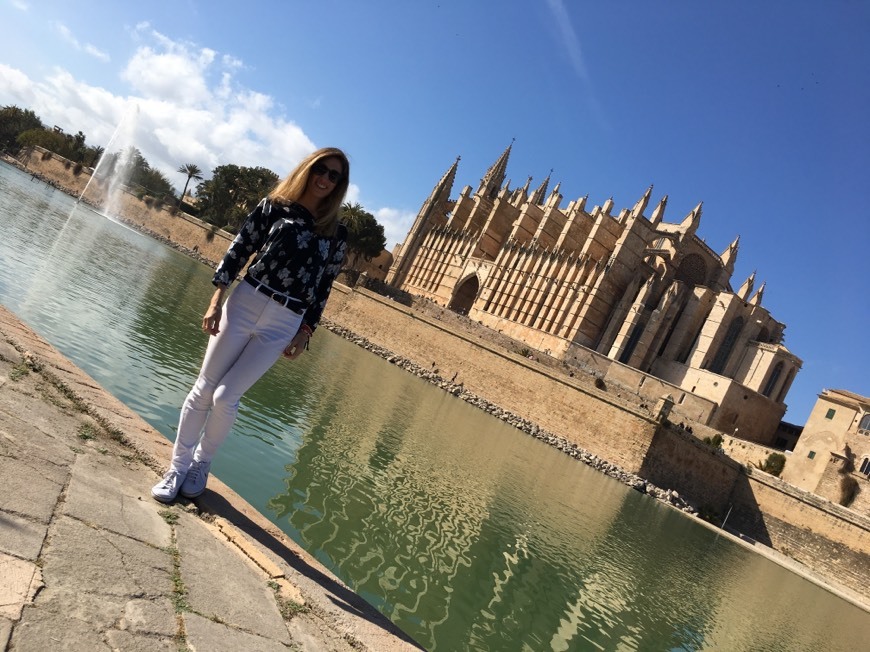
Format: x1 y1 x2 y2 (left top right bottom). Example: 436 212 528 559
63 453 172 548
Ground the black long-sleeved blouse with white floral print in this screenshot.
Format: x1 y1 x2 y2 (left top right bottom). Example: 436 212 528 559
212 199 347 330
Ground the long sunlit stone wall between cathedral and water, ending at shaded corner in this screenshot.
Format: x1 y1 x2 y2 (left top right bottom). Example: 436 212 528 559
324 289 657 472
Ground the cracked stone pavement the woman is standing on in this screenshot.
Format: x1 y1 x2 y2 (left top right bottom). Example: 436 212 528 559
0 307 421 652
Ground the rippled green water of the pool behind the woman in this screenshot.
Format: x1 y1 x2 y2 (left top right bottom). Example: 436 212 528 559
0 160 870 652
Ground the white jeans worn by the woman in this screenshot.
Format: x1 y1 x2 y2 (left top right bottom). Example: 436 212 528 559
172 282 302 473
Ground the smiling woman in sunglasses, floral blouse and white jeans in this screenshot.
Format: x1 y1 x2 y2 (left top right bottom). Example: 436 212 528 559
151 147 350 503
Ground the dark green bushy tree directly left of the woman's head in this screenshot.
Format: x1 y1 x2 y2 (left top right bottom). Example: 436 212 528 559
196 165 278 233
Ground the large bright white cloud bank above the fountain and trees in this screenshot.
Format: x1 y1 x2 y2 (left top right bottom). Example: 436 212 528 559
0 23 320 195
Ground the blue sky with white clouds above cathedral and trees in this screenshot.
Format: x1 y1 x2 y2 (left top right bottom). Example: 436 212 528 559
0 0 870 424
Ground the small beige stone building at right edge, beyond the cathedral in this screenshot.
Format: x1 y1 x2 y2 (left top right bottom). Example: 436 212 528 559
782 389 870 514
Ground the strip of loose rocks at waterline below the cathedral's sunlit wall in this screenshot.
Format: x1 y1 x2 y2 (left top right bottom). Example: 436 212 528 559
322 320 698 514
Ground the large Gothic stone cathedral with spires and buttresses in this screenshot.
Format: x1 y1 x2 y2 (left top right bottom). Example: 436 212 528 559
387 147 801 443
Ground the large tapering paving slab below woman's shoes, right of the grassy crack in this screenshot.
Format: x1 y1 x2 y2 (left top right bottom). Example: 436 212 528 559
176 515 290 649
